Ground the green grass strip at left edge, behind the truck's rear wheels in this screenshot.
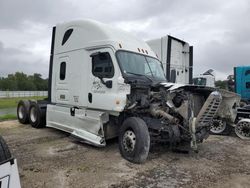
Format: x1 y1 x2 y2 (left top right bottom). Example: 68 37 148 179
0 97 46 109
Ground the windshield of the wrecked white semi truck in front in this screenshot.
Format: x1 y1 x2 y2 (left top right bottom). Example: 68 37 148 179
117 51 166 80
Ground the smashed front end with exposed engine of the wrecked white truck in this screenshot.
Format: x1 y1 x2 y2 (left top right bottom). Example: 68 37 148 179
126 83 238 150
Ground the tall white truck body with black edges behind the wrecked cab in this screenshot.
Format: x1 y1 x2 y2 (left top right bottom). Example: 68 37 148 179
147 35 193 84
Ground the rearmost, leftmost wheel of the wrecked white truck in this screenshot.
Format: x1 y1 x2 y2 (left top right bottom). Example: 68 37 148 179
17 100 30 124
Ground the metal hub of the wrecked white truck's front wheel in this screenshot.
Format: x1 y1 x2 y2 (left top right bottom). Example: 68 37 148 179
122 130 136 153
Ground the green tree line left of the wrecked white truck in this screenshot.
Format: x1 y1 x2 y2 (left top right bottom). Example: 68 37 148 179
0 72 48 91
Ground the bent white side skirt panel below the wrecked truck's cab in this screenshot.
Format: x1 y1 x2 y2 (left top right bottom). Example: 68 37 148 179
46 105 109 147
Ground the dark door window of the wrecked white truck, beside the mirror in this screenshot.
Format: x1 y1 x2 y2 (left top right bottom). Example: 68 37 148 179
92 52 114 78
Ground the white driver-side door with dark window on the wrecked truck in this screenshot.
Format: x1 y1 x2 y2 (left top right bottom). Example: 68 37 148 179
88 48 120 111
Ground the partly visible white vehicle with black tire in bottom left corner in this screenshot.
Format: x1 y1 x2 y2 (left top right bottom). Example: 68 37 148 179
0 136 21 188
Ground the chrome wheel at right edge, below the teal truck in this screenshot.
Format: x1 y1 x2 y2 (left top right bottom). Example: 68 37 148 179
235 119 250 140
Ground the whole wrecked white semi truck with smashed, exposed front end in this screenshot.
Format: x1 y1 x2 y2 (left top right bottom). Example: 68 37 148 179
17 20 238 163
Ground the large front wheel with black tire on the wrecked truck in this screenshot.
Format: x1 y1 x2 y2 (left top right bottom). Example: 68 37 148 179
119 117 150 164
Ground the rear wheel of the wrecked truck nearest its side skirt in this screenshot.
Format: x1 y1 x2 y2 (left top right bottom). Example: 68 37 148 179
29 102 46 128
